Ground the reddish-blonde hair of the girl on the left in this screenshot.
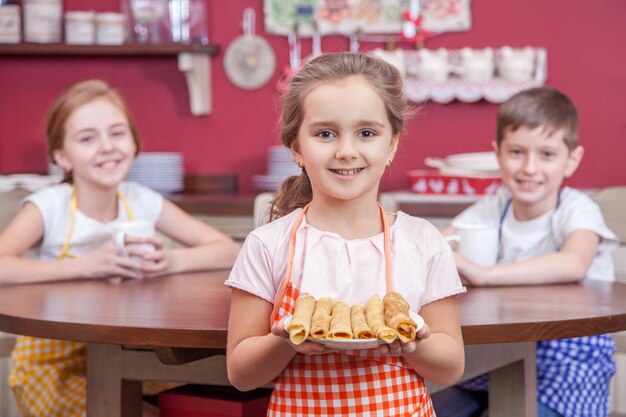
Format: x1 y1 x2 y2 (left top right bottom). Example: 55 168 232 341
46 80 141 182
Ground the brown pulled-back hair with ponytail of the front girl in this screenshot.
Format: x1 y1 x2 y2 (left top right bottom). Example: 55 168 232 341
270 52 413 220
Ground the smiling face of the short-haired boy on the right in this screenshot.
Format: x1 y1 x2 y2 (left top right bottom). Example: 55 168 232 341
494 126 584 220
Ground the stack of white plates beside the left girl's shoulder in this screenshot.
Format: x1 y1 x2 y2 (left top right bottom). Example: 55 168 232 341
126 152 185 194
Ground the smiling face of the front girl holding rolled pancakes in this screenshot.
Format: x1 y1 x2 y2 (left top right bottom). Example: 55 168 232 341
292 77 398 206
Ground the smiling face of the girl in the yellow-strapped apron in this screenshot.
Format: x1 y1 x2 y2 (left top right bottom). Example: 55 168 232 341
54 98 137 188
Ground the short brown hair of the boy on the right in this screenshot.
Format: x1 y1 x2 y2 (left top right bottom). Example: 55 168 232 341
497 87 578 151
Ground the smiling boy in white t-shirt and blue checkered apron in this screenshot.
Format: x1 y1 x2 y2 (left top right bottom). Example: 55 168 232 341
433 87 617 417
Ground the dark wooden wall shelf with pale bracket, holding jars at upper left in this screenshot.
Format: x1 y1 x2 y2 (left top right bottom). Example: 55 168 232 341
0 43 220 116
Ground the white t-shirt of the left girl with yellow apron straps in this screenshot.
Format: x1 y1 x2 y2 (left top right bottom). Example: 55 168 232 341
22 182 163 259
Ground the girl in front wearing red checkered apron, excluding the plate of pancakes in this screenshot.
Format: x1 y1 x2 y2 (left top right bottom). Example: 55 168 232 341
226 53 465 416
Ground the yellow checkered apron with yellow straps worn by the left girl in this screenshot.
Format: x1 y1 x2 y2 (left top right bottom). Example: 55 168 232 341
9 192 135 417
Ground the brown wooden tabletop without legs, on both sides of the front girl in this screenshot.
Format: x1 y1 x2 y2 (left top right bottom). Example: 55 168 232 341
0 270 626 349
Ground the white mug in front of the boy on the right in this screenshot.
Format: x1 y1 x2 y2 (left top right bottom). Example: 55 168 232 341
446 224 500 266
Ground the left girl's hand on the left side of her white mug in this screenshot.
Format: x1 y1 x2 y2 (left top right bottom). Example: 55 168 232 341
76 239 143 279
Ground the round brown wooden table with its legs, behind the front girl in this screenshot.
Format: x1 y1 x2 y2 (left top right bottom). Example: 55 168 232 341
0 271 626 417
